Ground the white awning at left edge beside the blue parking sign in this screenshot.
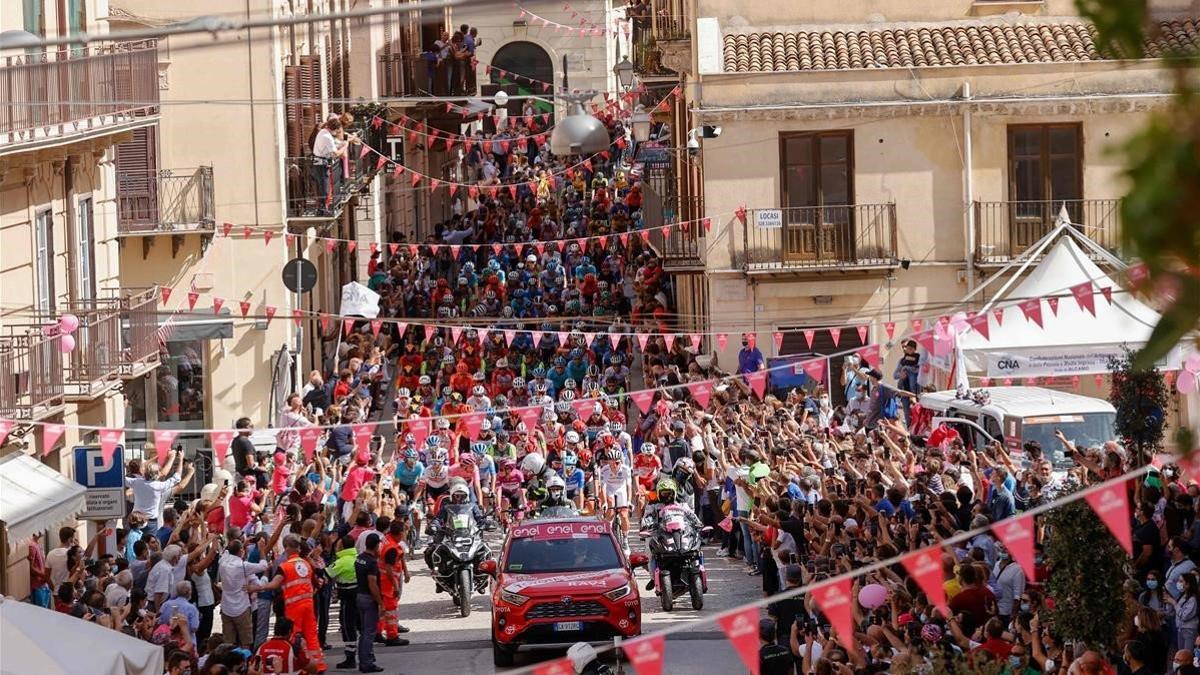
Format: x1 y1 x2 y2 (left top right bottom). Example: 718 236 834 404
0 453 86 549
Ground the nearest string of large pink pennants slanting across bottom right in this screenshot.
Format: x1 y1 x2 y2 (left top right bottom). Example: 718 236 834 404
511 461 1171 675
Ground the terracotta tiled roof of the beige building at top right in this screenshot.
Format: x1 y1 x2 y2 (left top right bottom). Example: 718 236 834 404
722 18 1200 72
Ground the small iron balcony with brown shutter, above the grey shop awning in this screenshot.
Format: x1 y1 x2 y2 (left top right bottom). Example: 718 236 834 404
116 167 216 237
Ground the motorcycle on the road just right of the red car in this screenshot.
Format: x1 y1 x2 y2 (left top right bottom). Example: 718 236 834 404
642 504 712 611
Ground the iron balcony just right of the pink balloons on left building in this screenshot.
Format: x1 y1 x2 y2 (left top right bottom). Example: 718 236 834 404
21 288 158 401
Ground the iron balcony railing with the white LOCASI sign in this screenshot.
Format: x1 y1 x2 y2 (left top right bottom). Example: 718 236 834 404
733 204 899 274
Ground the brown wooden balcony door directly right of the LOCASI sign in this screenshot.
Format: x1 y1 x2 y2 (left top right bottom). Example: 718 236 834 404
780 131 854 259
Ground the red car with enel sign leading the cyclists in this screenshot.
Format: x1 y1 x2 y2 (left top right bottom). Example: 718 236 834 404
480 518 649 667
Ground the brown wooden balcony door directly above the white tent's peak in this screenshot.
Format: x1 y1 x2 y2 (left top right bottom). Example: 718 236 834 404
1008 124 1084 251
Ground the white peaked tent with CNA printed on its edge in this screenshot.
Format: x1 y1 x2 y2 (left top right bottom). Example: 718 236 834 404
956 211 1182 378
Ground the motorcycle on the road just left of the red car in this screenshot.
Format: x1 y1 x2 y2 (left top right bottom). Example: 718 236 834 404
426 503 492 617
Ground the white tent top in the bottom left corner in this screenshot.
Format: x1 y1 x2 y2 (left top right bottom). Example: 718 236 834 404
0 596 163 675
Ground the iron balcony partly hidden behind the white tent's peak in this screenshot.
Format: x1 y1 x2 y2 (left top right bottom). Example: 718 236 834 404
974 199 1121 265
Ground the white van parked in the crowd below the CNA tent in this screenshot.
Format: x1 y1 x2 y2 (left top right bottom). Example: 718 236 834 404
920 387 1117 468
